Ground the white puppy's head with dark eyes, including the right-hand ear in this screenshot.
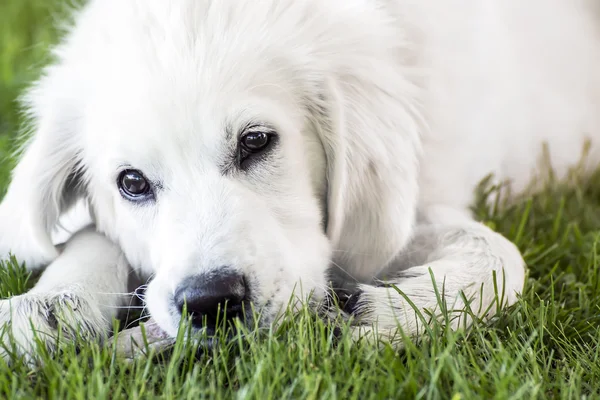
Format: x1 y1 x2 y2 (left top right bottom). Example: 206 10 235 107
16 0 419 334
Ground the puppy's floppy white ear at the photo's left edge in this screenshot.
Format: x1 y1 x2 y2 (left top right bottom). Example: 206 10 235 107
0 78 82 268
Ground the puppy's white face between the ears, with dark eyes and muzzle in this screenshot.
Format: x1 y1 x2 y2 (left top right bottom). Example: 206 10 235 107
79 61 329 333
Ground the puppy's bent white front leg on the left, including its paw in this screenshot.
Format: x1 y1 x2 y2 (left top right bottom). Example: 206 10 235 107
0 228 129 357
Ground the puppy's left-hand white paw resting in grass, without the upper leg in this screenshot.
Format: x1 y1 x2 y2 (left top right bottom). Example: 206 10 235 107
0 290 109 360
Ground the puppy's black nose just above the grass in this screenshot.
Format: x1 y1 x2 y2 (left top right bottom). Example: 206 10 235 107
174 270 247 333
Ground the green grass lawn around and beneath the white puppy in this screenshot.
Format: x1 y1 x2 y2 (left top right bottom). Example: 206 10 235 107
0 0 600 399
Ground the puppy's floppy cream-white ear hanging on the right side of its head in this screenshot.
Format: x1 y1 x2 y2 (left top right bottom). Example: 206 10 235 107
318 77 421 279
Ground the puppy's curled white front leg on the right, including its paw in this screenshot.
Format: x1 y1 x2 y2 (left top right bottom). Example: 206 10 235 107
345 207 525 339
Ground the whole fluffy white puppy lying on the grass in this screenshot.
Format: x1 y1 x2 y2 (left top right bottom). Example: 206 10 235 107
0 0 600 358
